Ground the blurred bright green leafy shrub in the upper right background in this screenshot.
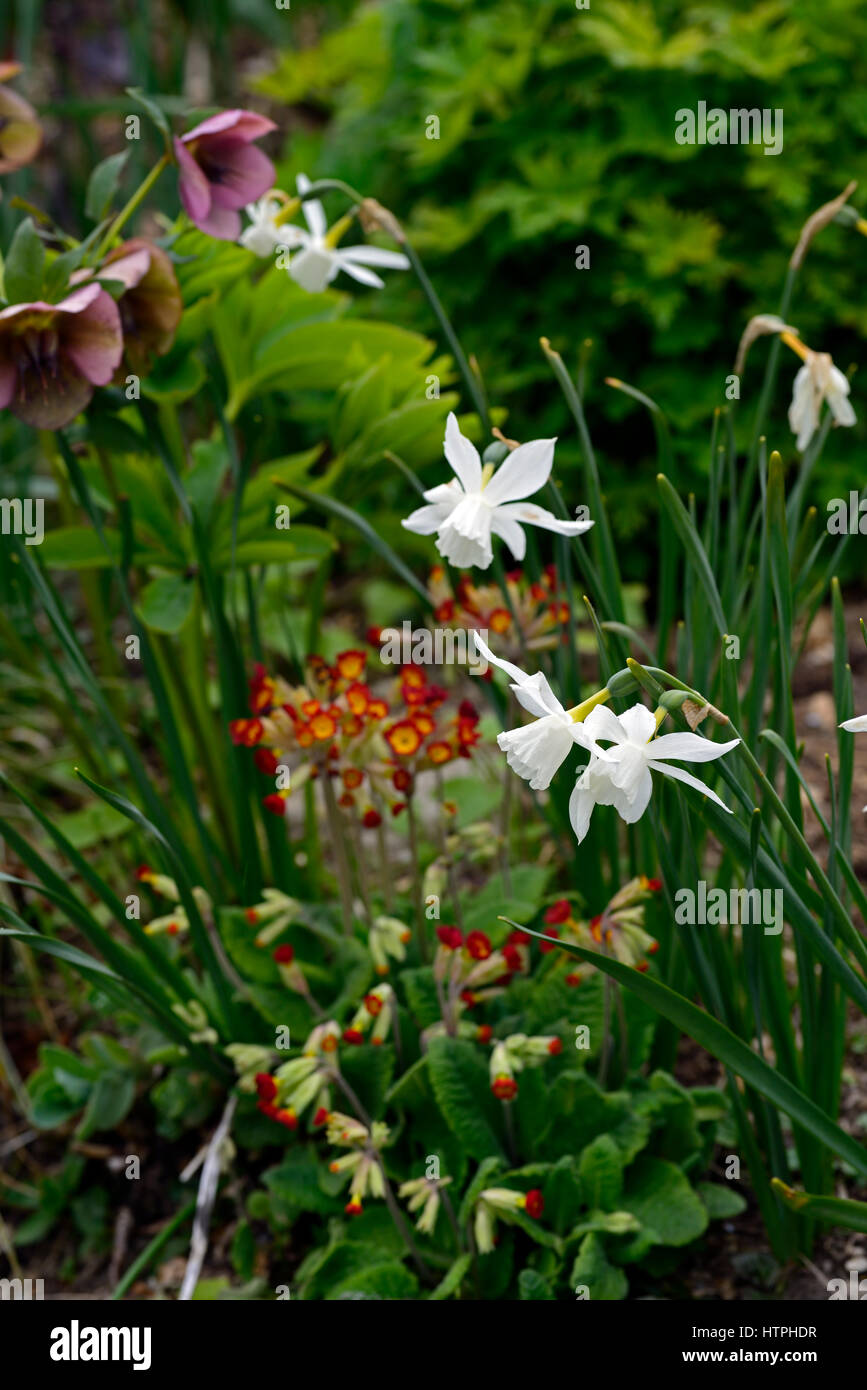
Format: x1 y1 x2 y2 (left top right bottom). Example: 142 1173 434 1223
256 0 867 567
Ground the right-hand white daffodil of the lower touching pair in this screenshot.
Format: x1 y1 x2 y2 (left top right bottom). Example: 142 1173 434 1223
570 705 741 844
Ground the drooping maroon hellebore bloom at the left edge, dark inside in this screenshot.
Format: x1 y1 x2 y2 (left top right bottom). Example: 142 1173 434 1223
0 285 124 430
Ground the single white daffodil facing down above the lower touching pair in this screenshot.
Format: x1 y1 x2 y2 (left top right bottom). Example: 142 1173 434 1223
402 414 593 570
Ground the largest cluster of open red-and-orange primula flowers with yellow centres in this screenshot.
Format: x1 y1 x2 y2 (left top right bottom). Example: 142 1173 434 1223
229 651 481 828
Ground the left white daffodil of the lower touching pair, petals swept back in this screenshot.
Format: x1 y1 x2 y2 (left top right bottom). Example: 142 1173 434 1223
472 632 589 791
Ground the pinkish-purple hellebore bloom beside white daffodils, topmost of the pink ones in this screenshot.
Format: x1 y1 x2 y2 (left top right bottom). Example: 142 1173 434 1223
175 110 276 242
